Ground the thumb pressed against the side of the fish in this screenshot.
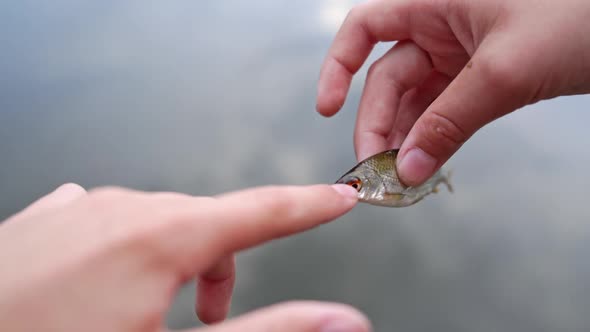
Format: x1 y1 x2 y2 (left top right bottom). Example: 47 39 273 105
397 40 541 186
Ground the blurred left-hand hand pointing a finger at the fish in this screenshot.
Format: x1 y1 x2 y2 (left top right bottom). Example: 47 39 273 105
0 184 369 332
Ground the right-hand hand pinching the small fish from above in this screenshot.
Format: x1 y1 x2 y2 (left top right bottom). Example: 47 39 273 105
317 0 590 185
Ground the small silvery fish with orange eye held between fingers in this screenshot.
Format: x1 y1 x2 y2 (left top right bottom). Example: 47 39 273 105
336 149 453 207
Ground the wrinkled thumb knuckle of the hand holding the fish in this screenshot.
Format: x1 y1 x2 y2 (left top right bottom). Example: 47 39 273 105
422 111 469 153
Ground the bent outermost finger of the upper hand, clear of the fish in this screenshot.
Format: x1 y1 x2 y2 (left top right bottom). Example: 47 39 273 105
316 0 416 116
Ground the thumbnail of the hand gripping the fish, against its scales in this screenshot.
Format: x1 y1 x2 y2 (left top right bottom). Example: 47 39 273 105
398 148 438 185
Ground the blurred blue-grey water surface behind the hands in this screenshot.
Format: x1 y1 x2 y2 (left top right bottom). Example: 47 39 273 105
0 0 590 332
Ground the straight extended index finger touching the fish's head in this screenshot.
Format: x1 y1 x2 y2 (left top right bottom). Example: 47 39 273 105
208 185 357 254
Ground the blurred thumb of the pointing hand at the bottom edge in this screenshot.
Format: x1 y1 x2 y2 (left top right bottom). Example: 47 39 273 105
187 302 371 332
